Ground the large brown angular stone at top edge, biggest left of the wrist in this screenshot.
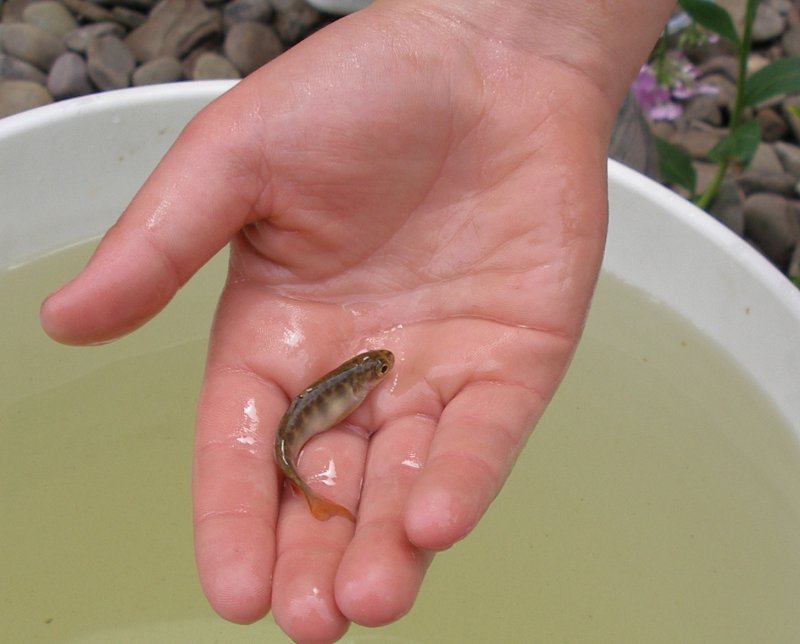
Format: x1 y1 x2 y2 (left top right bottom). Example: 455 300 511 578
125 0 222 62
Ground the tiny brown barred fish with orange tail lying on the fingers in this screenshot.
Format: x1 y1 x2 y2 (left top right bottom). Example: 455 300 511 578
275 349 394 521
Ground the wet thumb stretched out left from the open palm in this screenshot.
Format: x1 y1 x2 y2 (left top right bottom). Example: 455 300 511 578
40 86 266 344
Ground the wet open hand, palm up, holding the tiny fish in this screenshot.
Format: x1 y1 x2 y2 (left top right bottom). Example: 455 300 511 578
42 2 669 641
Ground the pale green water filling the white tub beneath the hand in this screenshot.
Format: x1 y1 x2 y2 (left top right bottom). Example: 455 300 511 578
0 247 800 644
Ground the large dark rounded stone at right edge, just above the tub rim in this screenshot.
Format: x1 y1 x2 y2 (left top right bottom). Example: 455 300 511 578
744 193 800 269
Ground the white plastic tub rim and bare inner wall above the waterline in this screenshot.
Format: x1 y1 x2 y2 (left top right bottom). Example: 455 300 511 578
0 81 800 431
